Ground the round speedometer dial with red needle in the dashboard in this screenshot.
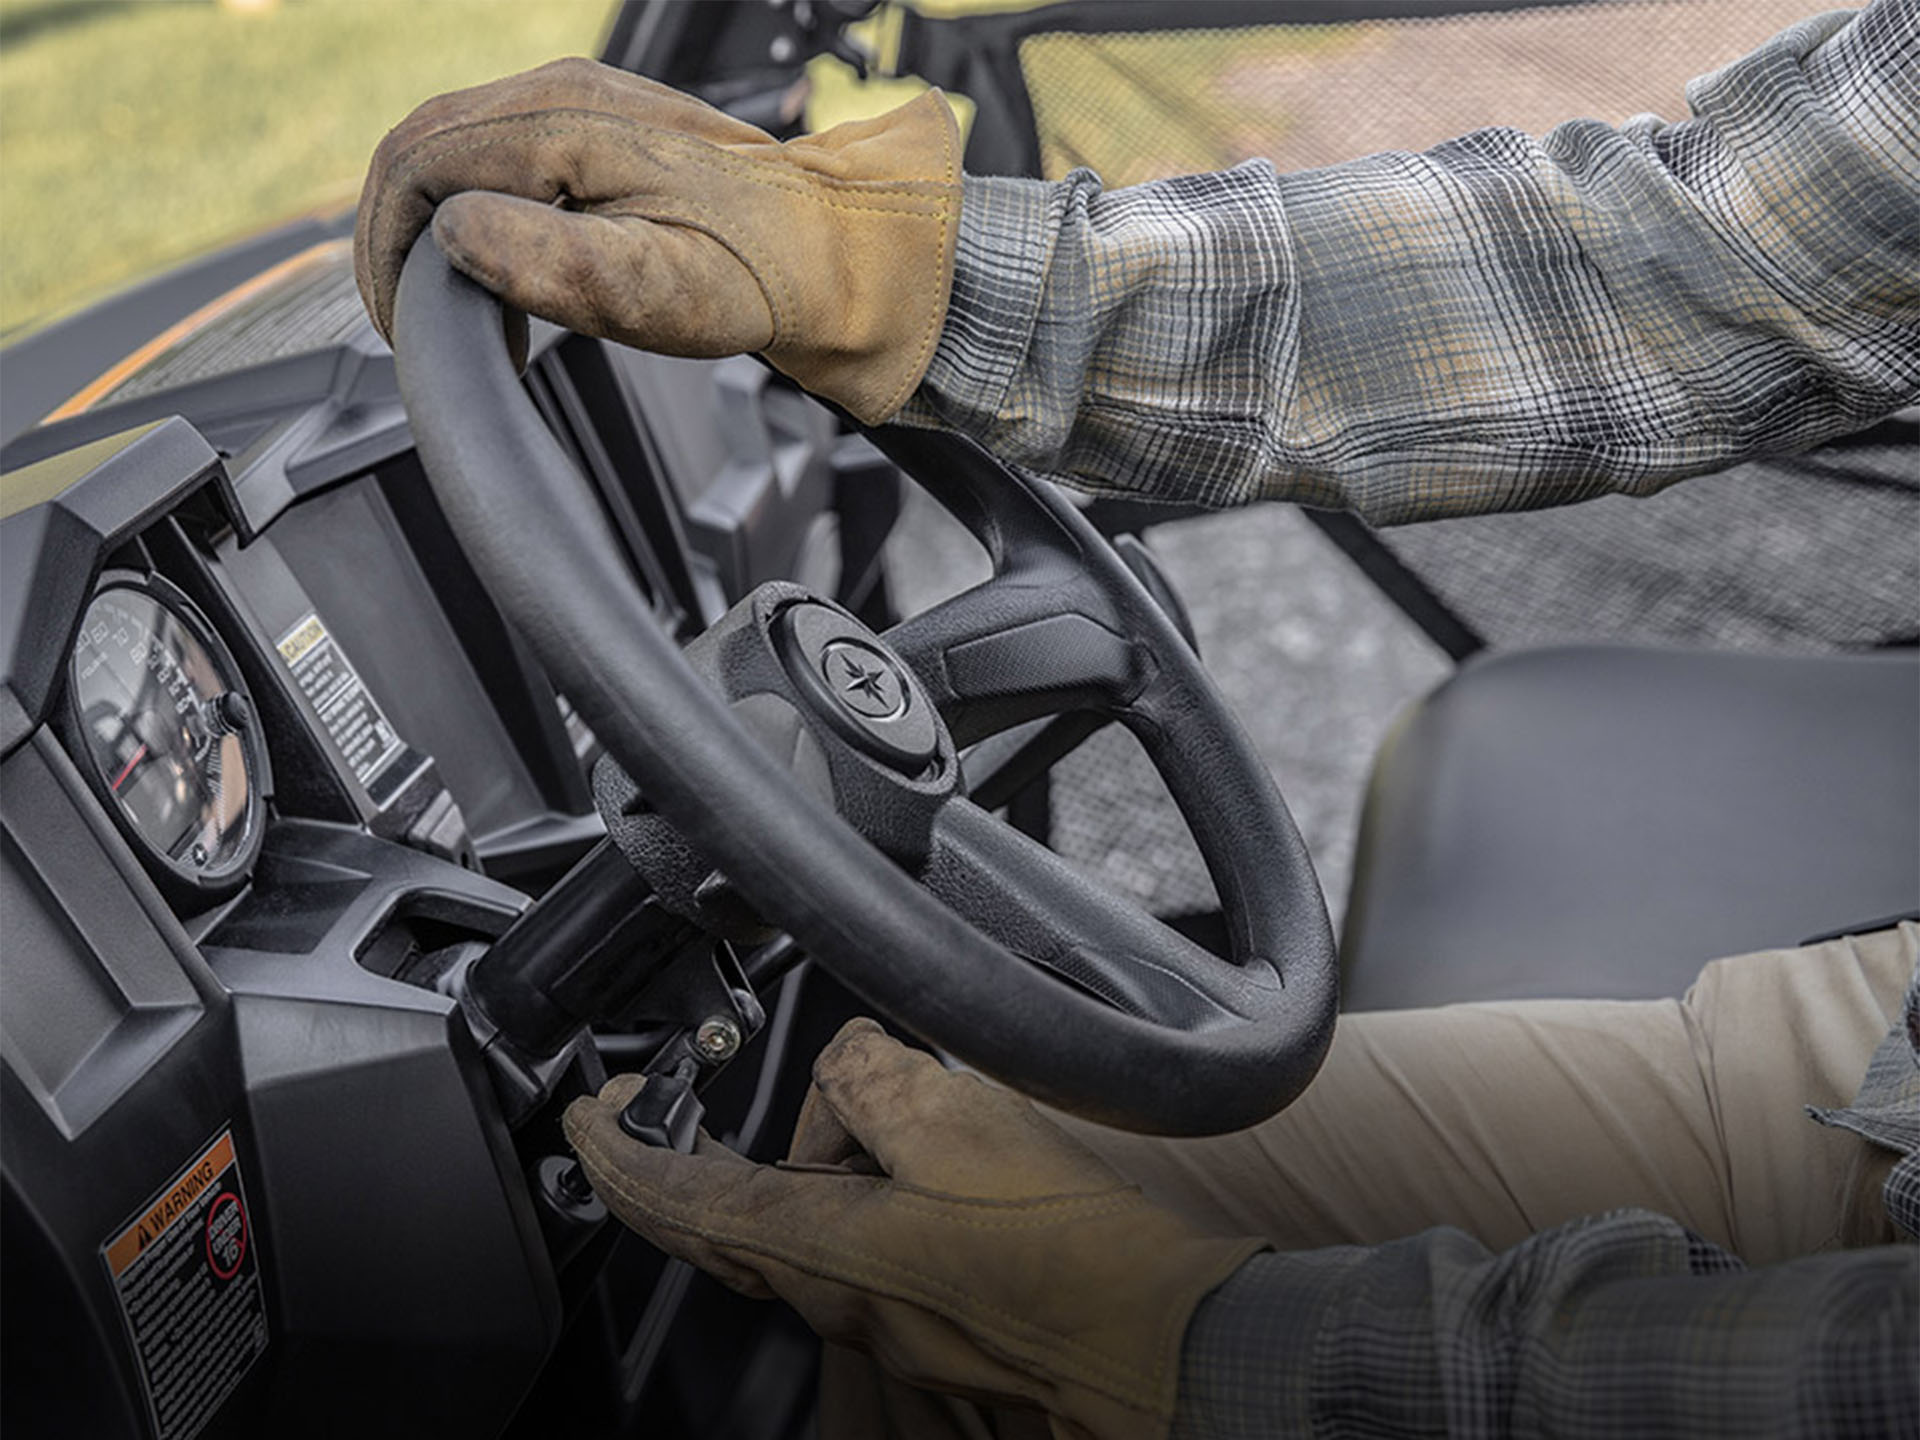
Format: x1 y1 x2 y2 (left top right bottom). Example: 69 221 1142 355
69 576 261 891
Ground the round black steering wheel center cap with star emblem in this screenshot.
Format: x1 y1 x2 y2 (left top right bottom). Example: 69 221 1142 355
780 603 939 774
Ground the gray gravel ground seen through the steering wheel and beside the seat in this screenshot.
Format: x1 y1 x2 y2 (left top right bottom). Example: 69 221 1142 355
887 490 1450 920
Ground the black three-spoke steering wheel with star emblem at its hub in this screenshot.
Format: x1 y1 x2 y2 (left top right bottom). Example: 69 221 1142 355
394 232 1338 1135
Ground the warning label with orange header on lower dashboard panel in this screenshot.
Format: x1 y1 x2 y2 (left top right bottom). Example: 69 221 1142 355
100 1131 267 1440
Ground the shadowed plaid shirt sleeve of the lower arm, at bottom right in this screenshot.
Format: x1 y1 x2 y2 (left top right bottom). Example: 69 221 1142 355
1173 1210 1920 1440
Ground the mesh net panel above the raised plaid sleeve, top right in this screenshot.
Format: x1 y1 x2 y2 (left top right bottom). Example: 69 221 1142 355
1020 0 1832 184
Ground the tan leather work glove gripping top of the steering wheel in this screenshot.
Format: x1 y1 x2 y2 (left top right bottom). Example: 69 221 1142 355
353 60 960 424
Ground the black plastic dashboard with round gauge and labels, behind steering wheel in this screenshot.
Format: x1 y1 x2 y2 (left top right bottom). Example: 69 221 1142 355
0 240 883 1440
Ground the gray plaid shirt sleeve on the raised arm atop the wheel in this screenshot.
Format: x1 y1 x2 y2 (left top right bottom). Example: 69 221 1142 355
902 0 1920 524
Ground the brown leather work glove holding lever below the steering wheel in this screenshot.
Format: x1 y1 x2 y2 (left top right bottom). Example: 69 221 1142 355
566 1020 1263 1440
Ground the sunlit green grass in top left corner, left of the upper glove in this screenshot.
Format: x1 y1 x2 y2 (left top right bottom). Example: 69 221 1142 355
0 0 612 332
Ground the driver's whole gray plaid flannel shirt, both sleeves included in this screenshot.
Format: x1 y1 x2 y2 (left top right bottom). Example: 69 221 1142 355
902 0 1920 1440
